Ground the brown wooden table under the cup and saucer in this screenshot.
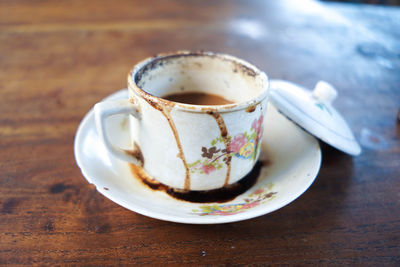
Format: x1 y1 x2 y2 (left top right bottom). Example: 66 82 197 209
0 0 400 266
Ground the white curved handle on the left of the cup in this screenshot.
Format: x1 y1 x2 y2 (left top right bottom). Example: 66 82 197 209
94 99 143 166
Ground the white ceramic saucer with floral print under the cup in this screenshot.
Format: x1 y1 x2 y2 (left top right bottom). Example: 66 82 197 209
74 89 321 224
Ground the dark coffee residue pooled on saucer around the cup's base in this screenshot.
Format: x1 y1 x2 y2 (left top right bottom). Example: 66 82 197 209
130 161 269 203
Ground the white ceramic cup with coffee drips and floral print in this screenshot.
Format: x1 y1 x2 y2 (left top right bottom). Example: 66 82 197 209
94 51 269 190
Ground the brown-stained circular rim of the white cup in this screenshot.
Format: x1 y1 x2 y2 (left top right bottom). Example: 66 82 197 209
128 50 270 113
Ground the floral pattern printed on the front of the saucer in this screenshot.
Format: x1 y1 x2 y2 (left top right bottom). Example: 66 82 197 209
192 183 277 216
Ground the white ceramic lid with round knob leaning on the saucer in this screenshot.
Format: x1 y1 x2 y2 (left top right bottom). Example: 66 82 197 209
270 80 361 156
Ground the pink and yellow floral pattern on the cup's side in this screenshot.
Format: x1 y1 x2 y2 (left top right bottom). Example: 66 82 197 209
188 115 264 174
